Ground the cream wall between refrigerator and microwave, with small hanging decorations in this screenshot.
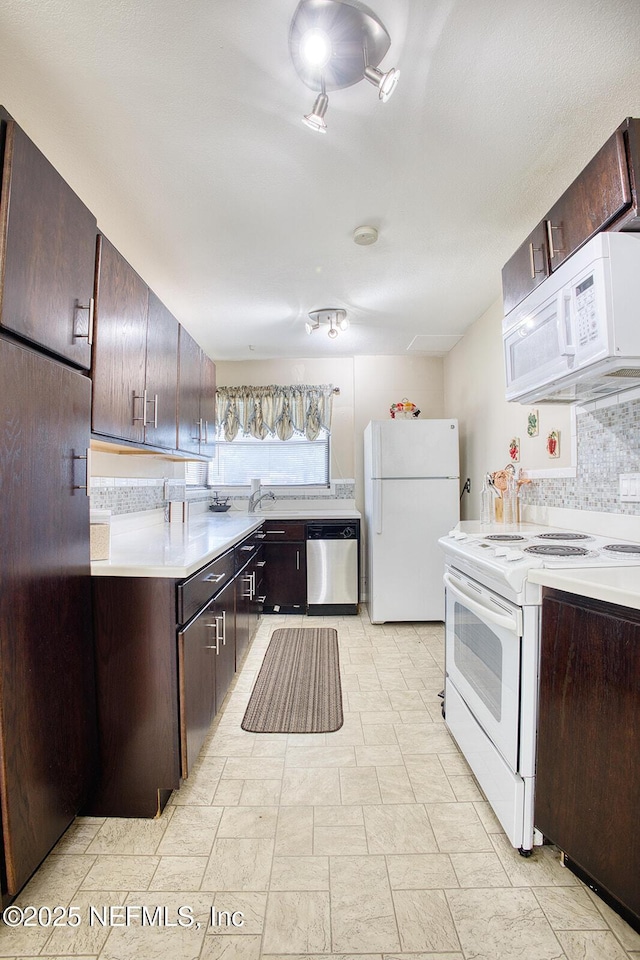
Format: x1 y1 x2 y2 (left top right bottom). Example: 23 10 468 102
444 300 571 519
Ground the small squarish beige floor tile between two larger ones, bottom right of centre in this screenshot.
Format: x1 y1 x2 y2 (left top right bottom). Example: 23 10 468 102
393 890 460 953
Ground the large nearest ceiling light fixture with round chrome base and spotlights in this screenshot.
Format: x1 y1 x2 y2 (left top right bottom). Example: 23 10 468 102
289 0 400 133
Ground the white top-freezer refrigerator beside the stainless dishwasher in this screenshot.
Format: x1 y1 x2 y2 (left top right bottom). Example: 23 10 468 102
364 420 460 623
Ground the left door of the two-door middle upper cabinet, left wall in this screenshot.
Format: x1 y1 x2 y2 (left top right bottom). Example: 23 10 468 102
91 236 148 443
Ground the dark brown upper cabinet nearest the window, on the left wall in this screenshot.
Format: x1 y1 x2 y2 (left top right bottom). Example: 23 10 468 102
178 327 216 457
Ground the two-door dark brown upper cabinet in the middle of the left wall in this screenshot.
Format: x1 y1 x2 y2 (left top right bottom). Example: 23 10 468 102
92 236 178 450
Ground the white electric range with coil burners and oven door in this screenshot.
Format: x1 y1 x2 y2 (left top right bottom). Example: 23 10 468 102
438 524 640 856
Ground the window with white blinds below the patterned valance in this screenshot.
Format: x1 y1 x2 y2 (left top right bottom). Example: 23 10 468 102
187 430 330 488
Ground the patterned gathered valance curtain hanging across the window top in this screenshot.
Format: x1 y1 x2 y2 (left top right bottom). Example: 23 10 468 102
216 384 334 440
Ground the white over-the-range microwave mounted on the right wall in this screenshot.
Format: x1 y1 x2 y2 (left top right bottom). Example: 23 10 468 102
502 232 640 403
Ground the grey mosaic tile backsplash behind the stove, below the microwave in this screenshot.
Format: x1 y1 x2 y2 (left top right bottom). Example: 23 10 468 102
520 399 640 516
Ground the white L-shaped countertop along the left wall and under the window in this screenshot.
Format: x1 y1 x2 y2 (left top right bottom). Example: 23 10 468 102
91 508 360 580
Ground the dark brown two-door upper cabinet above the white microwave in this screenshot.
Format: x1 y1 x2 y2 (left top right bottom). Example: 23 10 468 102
502 118 640 313
